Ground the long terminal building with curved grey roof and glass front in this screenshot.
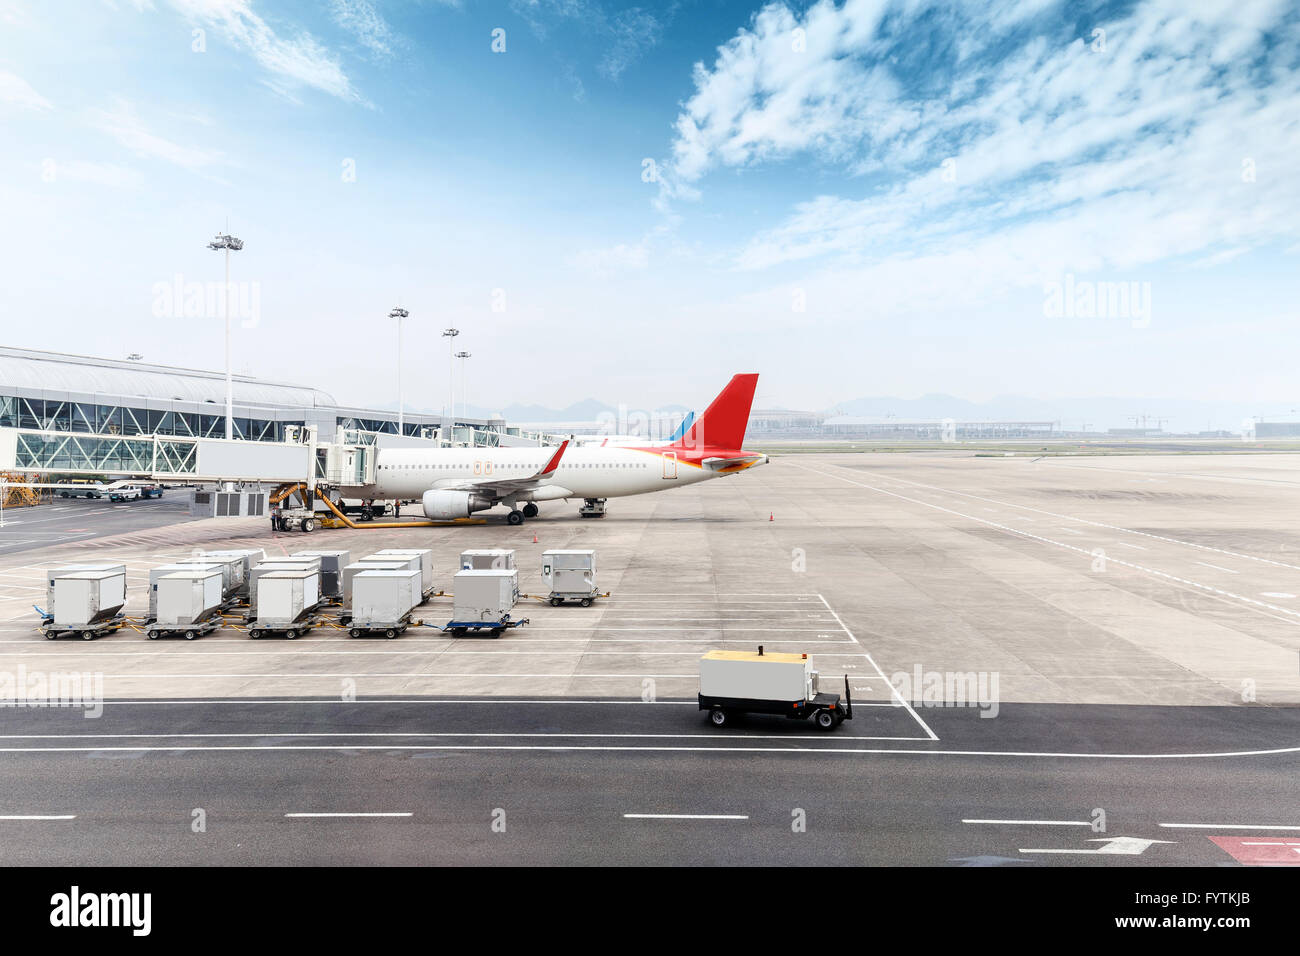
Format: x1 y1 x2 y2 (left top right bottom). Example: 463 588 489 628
0 347 536 475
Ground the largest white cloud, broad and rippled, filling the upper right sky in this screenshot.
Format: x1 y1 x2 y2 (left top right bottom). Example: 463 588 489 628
664 0 1300 311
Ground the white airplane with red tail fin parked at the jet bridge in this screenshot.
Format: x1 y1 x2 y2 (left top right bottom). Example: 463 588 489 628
341 373 767 524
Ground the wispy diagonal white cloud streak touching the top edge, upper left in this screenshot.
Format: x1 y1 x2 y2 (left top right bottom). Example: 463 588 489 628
170 0 361 101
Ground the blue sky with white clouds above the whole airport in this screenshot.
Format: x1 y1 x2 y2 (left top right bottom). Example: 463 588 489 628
0 0 1300 426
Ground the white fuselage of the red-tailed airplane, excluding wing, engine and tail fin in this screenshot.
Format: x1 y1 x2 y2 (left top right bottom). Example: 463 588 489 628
347 446 720 501
